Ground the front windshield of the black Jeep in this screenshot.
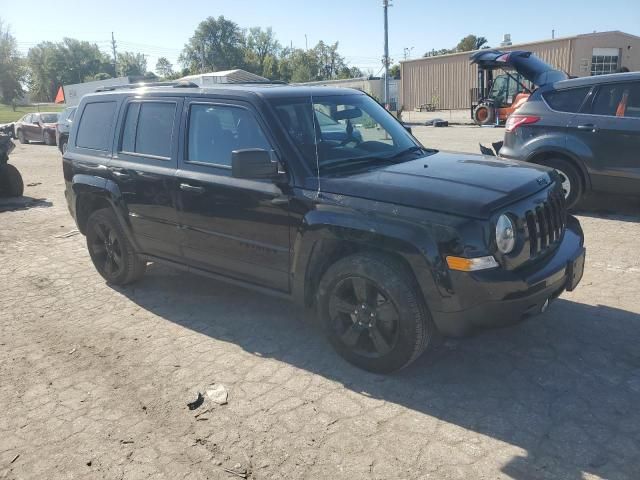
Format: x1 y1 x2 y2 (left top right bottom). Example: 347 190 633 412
272 94 424 173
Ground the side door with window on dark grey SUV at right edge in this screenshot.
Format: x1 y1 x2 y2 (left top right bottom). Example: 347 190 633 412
571 82 640 194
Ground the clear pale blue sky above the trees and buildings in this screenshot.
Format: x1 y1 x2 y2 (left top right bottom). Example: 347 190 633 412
5 0 640 73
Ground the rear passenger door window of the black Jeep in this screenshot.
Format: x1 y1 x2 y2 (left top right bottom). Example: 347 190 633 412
120 102 176 158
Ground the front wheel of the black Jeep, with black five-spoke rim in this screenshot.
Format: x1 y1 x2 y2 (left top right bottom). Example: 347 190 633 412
317 253 436 373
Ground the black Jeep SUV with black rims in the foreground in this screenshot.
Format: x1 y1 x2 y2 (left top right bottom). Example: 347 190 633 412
63 84 585 372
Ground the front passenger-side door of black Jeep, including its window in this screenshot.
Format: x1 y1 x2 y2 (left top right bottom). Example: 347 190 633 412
178 100 290 291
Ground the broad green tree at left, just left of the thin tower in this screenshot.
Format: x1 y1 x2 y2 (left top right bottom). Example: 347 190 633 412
27 38 113 101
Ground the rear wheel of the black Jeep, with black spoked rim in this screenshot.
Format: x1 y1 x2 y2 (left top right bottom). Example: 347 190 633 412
86 208 147 285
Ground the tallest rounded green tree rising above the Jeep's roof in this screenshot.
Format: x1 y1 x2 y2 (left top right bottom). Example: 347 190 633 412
178 15 245 73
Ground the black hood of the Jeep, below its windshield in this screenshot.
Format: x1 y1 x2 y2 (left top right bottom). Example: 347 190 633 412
305 152 553 218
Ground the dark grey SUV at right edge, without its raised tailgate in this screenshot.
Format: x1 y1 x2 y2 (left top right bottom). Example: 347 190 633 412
500 73 640 207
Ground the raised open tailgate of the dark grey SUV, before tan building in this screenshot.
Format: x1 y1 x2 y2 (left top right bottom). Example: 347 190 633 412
470 50 569 87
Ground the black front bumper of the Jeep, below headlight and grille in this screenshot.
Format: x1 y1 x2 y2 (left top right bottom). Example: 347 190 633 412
431 216 585 336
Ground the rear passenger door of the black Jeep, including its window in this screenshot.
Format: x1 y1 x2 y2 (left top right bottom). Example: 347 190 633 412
109 97 183 260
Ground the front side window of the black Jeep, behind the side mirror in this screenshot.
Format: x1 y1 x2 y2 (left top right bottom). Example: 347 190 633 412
187 105 271 165
